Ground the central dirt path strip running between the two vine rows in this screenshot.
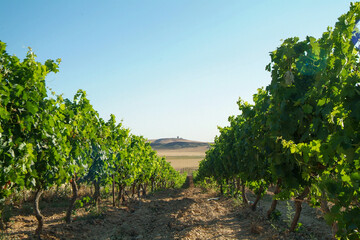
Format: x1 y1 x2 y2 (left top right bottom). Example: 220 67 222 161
88 177 275 240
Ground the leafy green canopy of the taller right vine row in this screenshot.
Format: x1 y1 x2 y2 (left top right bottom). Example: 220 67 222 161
196 3 360 239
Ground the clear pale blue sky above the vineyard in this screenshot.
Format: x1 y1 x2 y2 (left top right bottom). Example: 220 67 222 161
0 0 351 141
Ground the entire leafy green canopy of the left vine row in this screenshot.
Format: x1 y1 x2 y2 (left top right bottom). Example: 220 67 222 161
0 41 186 234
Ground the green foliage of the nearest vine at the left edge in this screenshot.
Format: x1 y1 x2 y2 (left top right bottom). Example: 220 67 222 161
0 42 60 202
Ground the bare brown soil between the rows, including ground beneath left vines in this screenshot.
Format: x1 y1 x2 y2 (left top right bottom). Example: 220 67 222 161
3 179 332 240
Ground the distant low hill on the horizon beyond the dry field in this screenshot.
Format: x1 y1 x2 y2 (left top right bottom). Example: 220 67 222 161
150 138 210 150
